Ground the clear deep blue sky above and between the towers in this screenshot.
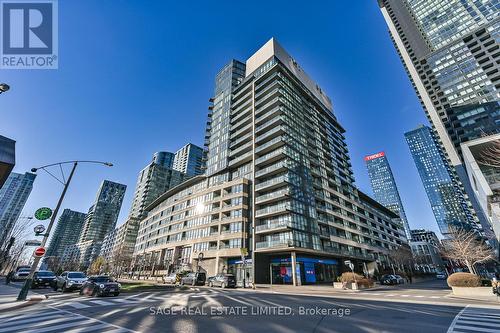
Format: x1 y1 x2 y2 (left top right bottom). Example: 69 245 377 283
0 0 438 236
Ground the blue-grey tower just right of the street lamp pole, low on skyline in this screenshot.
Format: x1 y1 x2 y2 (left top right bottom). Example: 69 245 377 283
45 209 86 258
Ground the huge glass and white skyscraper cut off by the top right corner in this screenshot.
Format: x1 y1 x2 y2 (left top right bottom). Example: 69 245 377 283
378 0 500 235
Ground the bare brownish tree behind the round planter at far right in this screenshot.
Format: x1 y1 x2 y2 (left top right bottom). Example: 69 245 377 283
442 227 495 274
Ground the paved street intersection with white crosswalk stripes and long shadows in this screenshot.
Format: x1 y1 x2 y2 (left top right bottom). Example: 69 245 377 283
0 278 500 333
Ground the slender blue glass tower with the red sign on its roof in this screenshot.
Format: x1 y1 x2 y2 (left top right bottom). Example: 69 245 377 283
365 152 411 241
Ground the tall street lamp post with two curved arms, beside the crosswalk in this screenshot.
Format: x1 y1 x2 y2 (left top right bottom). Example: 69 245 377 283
17 161 113 301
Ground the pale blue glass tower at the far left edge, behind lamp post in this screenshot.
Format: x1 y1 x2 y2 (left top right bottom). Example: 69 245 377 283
0 172 36 248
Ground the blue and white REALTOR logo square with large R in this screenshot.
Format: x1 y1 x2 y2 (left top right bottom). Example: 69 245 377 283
0 0 58 69
